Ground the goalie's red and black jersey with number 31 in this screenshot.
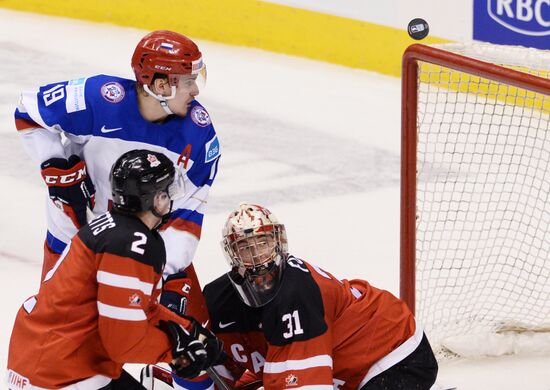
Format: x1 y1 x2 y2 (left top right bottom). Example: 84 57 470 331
204 256 423 390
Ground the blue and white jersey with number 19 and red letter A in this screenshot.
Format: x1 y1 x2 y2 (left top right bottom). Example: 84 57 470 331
15 75 220 274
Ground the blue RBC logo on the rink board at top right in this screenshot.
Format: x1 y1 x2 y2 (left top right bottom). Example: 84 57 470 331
487 0 550 36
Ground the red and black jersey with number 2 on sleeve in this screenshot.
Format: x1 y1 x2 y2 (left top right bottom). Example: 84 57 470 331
8 212 189 389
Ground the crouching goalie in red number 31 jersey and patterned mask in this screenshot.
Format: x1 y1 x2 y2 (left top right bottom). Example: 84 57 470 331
204 204 438 390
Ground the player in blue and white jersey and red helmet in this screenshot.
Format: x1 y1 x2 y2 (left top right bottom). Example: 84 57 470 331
15 31 220 336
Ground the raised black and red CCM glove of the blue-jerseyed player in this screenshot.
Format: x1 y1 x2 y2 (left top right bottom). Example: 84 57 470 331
40 155 95 228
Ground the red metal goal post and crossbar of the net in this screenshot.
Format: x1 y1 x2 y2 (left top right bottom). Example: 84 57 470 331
399 44 550 313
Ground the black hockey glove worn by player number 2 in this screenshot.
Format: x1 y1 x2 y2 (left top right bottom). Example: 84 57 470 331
160 320 207 378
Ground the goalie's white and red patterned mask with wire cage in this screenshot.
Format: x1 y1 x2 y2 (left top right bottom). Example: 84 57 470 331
221 203 288 307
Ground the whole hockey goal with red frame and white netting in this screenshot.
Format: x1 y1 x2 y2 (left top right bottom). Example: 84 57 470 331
400 43 550 357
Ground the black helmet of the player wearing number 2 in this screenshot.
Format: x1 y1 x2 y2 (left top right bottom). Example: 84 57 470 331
109 149 176 213
